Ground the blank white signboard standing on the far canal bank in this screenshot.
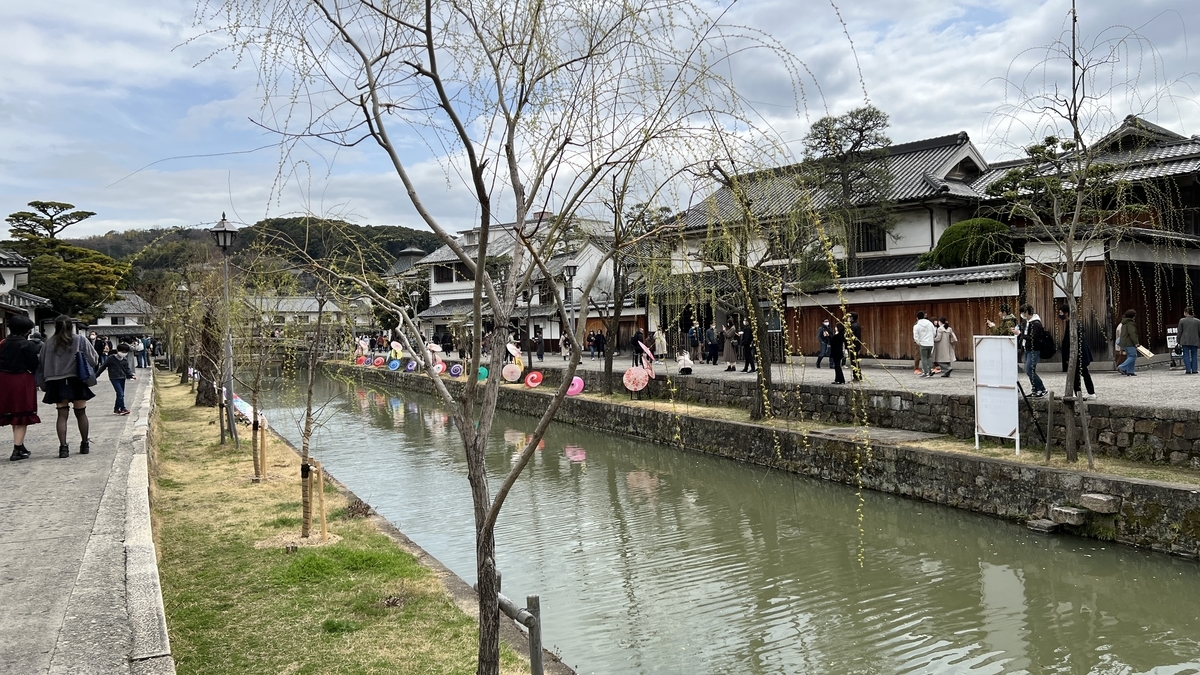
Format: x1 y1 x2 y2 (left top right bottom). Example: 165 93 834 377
974 335 1021 454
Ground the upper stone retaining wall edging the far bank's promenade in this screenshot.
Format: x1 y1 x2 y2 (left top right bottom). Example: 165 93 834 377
530 369 1200 470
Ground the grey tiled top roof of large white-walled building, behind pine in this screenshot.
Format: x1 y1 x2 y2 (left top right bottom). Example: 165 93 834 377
678 131 986 231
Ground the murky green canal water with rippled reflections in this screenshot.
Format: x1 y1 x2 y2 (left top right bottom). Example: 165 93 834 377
260 372 1200 675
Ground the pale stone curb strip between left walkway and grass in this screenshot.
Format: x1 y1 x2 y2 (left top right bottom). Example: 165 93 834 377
125 369 175 675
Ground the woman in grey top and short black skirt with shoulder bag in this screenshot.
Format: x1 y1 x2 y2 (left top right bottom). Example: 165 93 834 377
36 316 100 458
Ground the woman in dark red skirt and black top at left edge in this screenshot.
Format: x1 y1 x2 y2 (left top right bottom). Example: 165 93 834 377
0 315 42 461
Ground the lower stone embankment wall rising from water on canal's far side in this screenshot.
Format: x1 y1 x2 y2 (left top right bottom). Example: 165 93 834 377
330 365 1200 558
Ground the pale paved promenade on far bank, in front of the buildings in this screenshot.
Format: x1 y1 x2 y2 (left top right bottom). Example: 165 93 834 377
506 353 1200 411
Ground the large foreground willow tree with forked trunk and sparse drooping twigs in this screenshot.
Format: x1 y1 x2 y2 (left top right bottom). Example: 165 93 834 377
200 0 799 674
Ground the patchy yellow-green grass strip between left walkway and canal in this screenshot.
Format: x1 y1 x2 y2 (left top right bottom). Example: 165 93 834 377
151 376 528 675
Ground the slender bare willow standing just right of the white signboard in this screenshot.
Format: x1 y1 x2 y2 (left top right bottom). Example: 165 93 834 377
986 7 1190 467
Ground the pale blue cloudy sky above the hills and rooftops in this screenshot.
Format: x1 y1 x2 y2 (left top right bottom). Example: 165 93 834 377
0 0 1200 237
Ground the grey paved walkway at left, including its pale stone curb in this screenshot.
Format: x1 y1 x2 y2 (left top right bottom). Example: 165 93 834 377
0 369 174 675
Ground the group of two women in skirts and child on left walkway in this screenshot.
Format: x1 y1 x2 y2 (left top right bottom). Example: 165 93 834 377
0 315 149 461
